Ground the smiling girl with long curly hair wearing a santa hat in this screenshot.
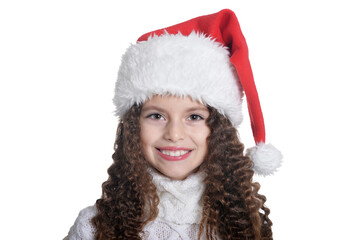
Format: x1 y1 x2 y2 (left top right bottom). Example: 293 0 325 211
67 9 281 240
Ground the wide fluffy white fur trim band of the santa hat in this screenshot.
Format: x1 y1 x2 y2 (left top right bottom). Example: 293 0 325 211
113 32 242 126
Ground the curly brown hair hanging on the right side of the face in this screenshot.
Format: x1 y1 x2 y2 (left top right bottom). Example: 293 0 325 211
199 108 273 240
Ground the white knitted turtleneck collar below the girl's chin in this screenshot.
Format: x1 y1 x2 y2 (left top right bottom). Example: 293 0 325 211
149 169 206 224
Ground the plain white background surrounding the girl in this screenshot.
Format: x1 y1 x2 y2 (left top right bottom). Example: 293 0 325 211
0 0 361 240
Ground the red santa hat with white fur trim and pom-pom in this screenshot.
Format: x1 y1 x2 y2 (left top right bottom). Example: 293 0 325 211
113 9 282 176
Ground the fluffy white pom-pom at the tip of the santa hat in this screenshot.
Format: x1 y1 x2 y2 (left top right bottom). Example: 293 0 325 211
246 142 282 176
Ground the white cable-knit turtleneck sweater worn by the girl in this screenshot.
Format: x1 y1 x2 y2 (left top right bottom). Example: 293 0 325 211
65 170 205 240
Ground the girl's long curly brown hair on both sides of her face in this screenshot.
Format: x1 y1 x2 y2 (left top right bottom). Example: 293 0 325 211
92 105 273 240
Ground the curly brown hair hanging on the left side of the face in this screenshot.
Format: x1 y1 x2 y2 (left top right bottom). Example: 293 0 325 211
92 106 159 240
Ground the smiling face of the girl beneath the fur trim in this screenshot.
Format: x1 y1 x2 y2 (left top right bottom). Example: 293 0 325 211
140 95 210 180
